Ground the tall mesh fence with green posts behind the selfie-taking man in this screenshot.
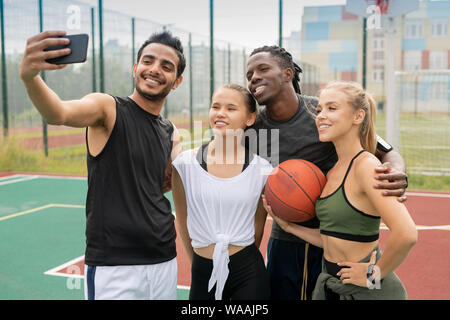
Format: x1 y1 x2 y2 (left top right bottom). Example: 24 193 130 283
0 0 282 154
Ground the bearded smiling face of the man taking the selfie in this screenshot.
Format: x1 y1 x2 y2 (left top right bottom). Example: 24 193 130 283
133 43 182 101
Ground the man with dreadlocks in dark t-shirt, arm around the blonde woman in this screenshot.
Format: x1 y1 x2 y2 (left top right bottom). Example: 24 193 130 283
246 46 407 300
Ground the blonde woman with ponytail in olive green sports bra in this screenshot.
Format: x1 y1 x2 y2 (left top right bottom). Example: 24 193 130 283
263 82 417 299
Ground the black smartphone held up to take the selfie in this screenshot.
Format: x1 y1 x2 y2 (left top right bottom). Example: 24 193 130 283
44 33 89 64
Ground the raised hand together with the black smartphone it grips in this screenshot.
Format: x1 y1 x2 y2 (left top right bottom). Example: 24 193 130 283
20 31 88 81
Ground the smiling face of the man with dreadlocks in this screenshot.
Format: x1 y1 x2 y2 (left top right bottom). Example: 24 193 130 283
246 52 289 105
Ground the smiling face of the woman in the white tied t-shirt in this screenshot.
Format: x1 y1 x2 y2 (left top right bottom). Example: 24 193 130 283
209 87 256 136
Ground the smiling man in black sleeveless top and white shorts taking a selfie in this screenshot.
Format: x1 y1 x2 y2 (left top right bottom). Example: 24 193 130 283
20 31 186 299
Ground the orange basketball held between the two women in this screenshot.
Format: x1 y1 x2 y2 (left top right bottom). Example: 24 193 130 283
264 159 326 222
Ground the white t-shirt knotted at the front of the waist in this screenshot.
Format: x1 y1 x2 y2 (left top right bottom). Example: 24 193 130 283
172 150 273 300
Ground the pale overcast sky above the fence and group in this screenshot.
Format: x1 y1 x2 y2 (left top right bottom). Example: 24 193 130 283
79 0 346 48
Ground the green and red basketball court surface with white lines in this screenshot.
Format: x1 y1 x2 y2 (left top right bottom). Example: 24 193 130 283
0 173 450 300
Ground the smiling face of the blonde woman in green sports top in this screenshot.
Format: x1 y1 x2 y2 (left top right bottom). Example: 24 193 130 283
316 88 365 142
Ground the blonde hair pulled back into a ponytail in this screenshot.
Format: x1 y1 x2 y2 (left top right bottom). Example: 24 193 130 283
322 81 377 154
